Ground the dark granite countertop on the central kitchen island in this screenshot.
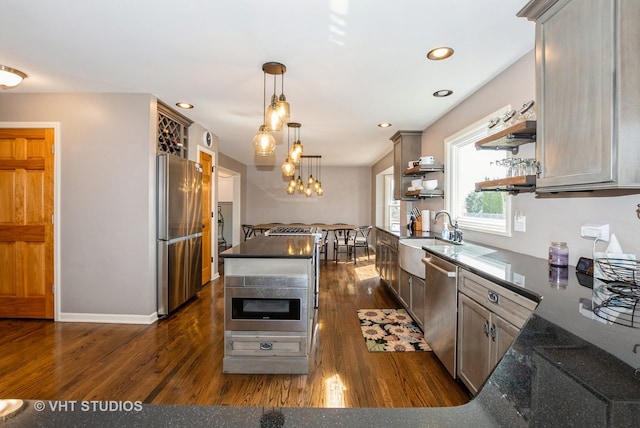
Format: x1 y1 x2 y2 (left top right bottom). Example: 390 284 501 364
220 235 315 259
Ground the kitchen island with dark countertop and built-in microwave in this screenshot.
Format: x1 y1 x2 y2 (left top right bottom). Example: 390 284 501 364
220 235 318 374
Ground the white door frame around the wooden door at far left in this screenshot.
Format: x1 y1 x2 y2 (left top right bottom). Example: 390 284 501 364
0 122 62 321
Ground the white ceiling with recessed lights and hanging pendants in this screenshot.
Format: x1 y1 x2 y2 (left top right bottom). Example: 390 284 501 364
0 0 534 166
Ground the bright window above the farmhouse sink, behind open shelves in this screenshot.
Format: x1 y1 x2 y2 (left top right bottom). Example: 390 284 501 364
445 106 511 236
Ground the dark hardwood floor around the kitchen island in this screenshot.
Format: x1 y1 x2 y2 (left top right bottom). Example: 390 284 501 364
0 256 469 407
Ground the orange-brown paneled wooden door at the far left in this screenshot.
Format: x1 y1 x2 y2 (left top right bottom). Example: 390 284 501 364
0 129 54 319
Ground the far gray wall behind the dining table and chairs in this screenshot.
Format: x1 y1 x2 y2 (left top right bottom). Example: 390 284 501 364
246 165 372 225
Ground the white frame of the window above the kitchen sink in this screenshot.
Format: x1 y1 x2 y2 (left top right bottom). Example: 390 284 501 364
444 105 512 237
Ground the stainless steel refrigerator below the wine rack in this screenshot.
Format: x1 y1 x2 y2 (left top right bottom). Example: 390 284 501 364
157 153 202 316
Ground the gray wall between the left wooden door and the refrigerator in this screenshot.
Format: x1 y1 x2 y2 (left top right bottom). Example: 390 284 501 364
0 94 156 322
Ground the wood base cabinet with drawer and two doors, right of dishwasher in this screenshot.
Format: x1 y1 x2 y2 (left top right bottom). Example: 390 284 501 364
457 269 537 395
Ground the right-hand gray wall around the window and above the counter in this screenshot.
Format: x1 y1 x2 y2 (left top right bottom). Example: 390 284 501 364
402 51 640 265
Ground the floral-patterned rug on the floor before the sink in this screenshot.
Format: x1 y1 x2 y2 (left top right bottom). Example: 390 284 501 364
358 309 431 352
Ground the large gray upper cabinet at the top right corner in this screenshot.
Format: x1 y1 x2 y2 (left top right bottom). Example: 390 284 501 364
518 0 640 192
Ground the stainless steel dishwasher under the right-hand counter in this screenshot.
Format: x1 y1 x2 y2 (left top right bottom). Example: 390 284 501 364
422 253 458 379
